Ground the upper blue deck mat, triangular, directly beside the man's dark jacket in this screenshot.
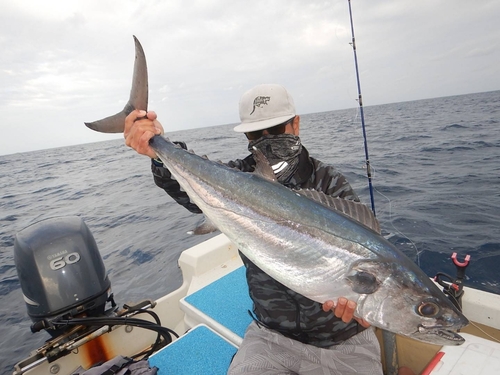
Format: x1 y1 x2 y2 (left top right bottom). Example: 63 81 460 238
185 266 253 337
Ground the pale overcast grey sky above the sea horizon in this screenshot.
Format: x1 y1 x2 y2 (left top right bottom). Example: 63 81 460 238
0 0 500 154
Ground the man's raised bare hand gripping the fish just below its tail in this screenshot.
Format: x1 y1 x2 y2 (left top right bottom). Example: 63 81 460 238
123 110 163 159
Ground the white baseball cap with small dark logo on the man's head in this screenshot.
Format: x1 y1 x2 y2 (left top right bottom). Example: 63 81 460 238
234 84 295 133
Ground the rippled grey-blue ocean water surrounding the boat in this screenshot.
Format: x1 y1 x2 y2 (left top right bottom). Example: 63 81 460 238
0 91 500 374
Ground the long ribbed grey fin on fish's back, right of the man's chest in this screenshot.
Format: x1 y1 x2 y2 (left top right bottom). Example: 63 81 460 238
297 189 380 234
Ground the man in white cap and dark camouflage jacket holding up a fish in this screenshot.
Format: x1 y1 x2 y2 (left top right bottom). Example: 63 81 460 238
124 84 382 375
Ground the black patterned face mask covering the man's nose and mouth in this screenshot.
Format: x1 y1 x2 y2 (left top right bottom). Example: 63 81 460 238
248 134 302 183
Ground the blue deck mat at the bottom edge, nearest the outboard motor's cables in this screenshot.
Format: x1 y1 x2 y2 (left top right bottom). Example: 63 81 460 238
149 326 236 375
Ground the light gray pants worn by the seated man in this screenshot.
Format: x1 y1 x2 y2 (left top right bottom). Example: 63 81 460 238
228 322 382 375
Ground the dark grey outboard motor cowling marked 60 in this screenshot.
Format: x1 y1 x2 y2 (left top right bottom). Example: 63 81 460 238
14 216 111 335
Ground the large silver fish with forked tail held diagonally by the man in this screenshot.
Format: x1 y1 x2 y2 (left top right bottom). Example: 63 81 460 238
85 36 468 345
